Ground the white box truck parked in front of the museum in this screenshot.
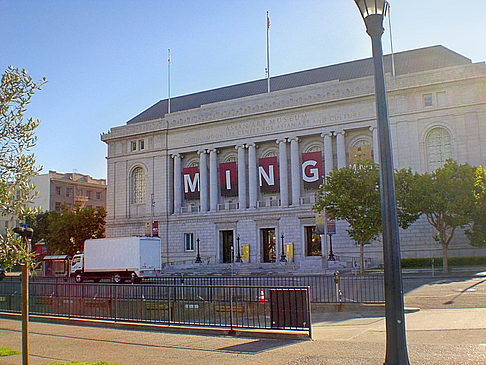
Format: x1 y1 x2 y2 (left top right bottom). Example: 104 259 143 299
71 237 162 283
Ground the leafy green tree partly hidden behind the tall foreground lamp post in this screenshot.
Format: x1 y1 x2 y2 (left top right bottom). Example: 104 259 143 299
314 160 420 273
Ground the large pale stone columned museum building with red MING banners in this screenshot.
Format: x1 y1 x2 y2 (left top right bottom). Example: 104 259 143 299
101 46 486 272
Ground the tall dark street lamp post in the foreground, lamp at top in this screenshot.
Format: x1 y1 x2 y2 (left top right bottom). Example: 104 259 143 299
355 0 409 365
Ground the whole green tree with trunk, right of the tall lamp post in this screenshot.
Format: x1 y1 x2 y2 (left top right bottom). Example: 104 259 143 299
416 160 475 272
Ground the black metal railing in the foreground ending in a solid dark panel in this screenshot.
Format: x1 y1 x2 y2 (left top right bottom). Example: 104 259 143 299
0 279 311 336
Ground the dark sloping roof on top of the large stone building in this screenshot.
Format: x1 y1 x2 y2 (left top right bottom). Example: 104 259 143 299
127 46 471 123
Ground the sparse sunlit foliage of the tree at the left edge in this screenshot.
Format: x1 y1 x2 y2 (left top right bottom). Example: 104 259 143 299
0 66 46 267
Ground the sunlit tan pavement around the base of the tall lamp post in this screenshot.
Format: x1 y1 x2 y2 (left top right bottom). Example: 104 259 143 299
0 277 486 365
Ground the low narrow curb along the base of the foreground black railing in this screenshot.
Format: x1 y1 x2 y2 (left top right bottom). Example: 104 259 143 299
0 312 312 341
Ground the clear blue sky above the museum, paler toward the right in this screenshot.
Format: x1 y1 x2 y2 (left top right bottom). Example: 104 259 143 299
0 0 486 178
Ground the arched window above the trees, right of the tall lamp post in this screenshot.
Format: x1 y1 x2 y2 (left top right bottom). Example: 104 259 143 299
425 127 452 171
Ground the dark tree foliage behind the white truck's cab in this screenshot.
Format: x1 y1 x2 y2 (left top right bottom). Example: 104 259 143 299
28 206 106 256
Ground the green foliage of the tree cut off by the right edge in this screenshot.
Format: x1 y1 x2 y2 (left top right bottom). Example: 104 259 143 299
465 166 486 247
